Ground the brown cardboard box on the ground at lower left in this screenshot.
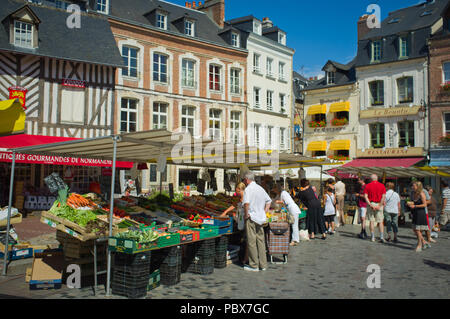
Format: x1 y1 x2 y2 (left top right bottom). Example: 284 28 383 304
30 250 65 290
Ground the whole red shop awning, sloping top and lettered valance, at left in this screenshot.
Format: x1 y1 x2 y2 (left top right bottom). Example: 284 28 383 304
0 134 133 169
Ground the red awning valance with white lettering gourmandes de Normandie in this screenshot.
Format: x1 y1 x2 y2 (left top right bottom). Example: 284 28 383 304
0 152 133 169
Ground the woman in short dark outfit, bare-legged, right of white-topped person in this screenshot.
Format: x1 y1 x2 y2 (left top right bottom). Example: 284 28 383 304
408 182 431 252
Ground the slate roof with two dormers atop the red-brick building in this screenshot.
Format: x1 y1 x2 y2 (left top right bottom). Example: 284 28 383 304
109 0 239 48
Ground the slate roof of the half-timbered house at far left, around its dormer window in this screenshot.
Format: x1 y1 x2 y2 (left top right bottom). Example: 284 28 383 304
0 0 123 67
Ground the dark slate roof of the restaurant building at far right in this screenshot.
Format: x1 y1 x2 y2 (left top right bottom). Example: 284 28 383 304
356 0 450 67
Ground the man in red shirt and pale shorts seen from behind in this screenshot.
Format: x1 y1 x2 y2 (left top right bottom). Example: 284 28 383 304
364 174 386 243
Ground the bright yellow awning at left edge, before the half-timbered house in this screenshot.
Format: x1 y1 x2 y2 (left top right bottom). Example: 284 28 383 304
0 99 26 134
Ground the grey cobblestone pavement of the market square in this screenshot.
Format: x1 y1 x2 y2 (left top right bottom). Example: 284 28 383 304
0 225 450 299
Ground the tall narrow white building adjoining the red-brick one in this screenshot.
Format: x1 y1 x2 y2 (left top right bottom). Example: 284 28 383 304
227 16 294 152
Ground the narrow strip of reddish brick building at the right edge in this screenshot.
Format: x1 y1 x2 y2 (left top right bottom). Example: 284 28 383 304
429 4 450 166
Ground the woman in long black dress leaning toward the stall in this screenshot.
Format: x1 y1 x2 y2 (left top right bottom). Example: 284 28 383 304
298 179 327 239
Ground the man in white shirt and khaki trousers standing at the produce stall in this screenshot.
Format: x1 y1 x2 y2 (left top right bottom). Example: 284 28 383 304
243 172 272 271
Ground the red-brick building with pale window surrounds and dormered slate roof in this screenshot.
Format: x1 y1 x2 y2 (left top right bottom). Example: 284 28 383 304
101 0 248 191
